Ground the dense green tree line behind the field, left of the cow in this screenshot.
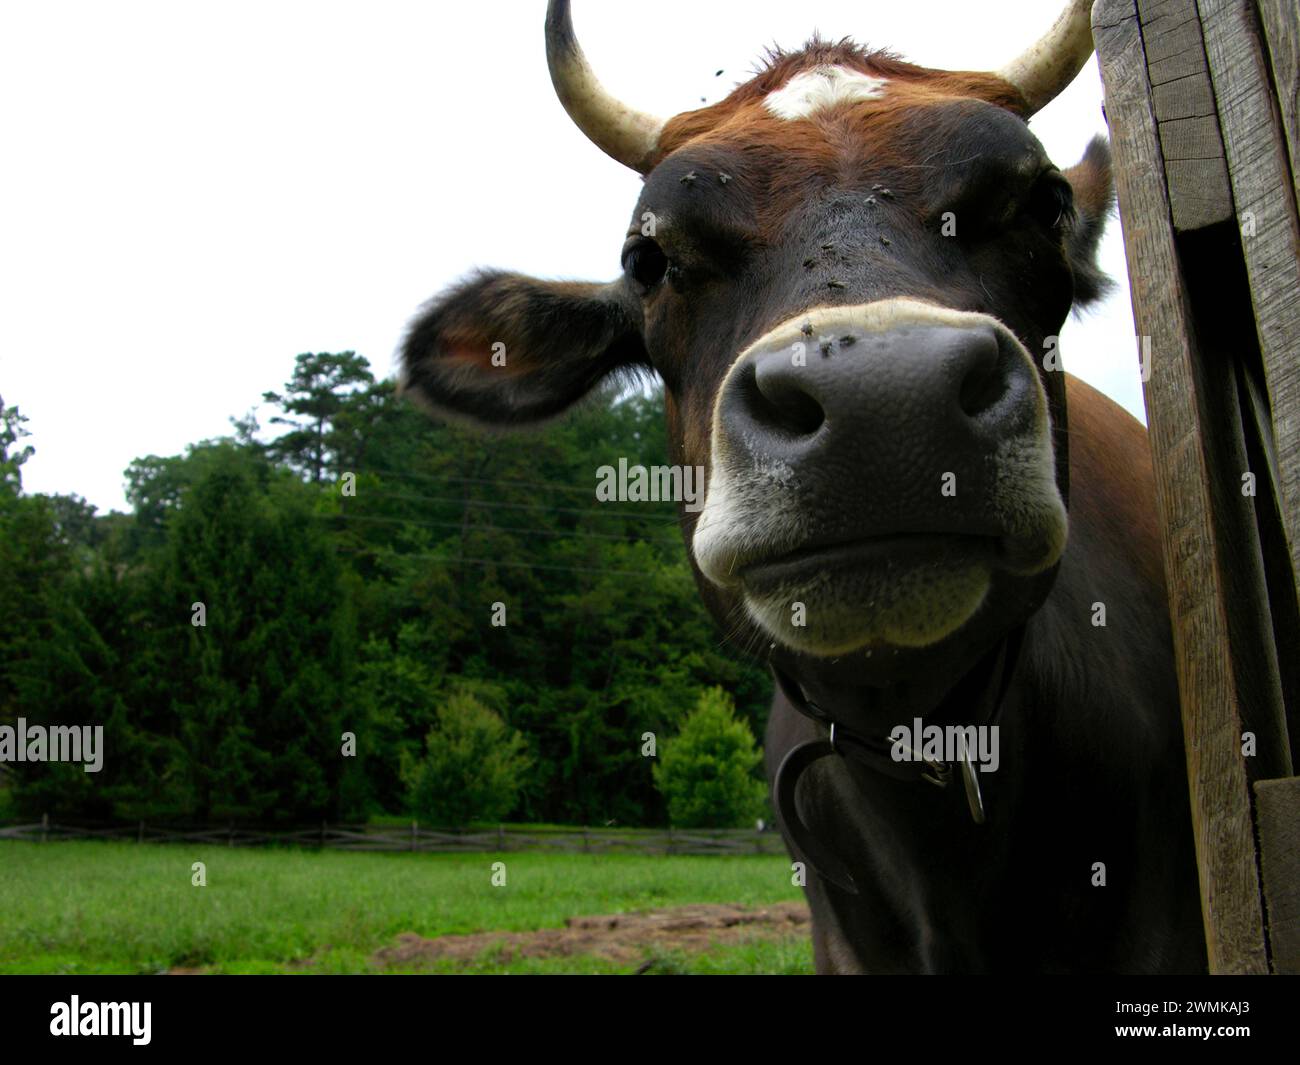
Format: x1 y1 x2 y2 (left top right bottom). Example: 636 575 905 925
0 352 771 824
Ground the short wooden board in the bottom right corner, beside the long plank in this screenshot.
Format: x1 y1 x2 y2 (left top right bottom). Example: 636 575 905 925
1255 776 1300 975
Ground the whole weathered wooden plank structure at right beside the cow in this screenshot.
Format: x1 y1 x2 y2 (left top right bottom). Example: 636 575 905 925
1092 0 1300 973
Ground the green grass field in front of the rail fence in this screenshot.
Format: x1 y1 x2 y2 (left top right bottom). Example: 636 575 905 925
0 841 813 973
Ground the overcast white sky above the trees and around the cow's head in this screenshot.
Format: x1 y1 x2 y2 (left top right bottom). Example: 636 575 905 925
0 0 1141 510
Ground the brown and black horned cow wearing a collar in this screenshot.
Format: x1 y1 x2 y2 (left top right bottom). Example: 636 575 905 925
400 0 1206 973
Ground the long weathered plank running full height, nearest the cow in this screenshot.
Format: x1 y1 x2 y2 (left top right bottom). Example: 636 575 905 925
1092 0 1268 973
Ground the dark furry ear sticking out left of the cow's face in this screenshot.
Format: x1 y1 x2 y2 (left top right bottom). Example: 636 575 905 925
402 272 647 428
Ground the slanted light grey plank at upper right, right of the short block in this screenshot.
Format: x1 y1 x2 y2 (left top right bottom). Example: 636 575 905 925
1200 0 1300 616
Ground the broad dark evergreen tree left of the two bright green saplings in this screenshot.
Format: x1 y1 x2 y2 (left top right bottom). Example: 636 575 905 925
164 446 352 819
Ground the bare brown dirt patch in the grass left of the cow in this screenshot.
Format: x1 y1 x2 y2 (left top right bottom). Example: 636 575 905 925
373 901 809 969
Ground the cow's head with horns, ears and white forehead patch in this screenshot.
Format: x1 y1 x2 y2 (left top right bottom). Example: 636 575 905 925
403 0 1112 684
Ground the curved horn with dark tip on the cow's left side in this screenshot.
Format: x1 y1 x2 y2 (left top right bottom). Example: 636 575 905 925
546 0 663 174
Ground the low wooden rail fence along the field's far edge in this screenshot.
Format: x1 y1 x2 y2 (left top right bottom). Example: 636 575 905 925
0 817 785 854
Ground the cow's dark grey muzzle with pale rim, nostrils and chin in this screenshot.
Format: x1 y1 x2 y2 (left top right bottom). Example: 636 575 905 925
694 300 1066 654
